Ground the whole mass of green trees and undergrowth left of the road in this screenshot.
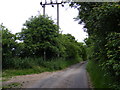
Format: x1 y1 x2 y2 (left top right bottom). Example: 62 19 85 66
1 15 86 70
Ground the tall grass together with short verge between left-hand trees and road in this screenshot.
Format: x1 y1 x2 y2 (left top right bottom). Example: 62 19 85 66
3 58 82 77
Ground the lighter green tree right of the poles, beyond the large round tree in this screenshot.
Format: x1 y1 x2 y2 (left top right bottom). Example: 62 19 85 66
60 34 86 60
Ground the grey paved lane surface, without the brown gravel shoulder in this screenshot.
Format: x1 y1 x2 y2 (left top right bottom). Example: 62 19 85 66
26 62 89 88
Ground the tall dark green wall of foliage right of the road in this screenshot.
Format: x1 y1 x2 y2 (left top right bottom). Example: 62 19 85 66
71 2 120 88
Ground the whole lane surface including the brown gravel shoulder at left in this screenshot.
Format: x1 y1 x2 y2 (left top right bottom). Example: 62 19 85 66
3 62 89 88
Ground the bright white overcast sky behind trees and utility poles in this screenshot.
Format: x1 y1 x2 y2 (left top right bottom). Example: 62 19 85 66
0 0 87 42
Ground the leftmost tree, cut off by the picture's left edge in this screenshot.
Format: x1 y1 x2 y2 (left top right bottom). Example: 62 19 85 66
1 25 17 60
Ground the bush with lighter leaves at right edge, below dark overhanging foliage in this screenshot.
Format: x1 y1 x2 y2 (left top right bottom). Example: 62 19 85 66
103 32 120 78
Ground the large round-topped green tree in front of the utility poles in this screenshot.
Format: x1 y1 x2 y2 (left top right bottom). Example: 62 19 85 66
19 15 59 58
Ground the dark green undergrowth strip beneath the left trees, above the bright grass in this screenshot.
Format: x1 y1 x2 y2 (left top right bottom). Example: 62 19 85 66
3 57 43 69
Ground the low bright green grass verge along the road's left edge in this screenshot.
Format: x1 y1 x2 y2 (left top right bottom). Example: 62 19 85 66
2 59 82 81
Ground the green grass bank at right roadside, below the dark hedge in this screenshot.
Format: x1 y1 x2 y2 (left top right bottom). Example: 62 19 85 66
87 60 120 90
